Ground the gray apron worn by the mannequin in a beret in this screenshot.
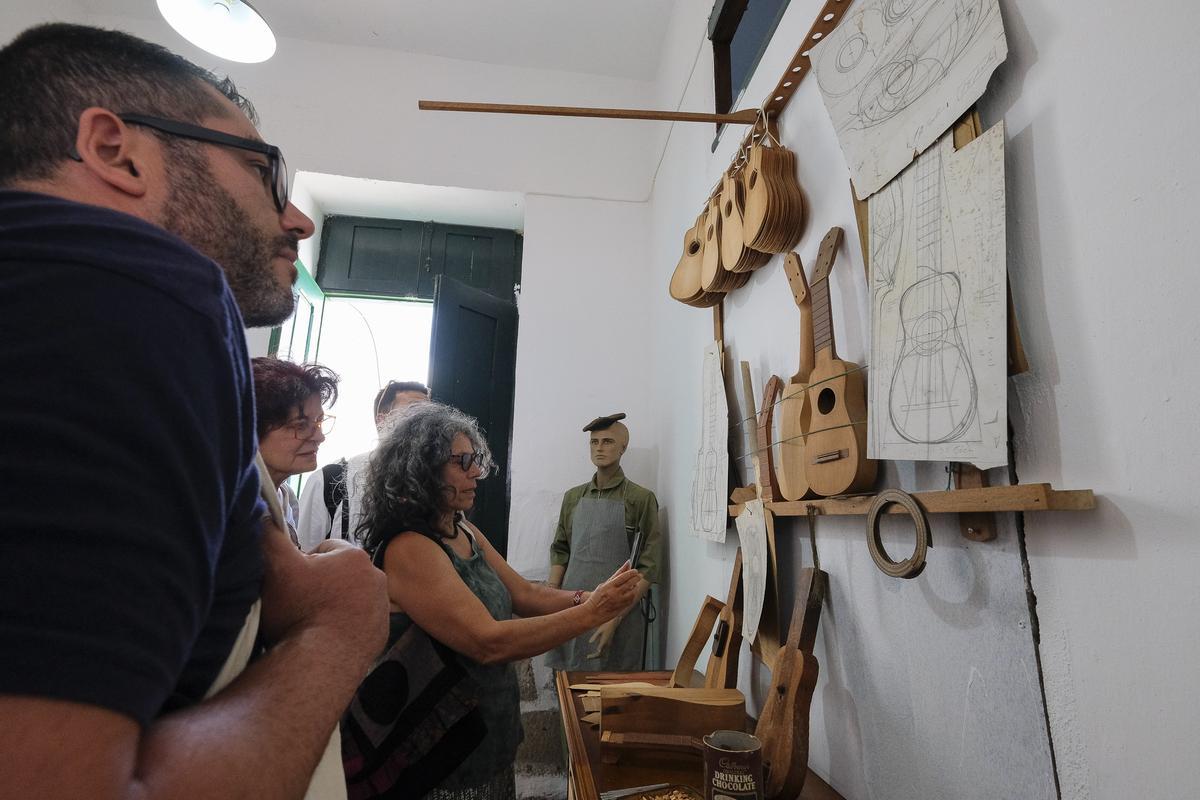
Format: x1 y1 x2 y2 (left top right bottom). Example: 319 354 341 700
546 492 644 672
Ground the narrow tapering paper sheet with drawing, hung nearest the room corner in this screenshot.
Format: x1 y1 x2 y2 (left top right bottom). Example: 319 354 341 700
691 342 730 542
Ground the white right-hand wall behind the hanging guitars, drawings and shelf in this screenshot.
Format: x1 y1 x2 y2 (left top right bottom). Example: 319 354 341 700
649 0 1200 800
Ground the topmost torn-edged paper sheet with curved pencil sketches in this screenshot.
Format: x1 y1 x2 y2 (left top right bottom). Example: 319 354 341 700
810 0 1008 198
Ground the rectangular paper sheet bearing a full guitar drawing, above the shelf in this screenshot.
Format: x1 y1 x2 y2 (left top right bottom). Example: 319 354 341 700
868 122 1008 468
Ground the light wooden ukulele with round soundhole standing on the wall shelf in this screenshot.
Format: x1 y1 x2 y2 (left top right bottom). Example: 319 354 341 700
804 227 877 497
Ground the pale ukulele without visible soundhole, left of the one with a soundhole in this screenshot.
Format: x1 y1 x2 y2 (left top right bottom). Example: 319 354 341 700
775 253 815 500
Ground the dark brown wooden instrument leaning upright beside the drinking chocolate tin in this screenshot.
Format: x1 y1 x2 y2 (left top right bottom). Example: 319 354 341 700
754 567 826 800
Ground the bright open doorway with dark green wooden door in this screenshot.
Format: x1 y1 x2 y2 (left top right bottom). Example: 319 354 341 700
286 173 524 553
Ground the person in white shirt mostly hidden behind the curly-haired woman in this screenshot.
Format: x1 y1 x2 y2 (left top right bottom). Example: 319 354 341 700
296 380 430 552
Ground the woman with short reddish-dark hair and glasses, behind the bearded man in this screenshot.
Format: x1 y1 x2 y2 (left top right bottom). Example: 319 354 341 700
251 357 337 547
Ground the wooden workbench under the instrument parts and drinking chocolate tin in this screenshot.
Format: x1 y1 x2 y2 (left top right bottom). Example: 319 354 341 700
554 672 842 800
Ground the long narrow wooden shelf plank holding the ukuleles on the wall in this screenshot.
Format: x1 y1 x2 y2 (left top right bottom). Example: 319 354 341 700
730 483 1096 517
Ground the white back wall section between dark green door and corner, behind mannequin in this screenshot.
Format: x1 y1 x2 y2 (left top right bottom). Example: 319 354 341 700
509 196 659 579
